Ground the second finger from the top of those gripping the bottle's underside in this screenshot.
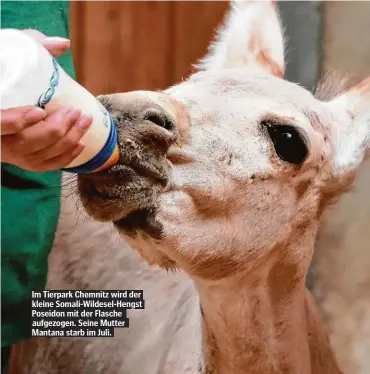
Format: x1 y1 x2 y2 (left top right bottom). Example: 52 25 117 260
12 108 81 155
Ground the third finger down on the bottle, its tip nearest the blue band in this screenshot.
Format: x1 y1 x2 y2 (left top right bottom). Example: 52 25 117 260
38 116 92 160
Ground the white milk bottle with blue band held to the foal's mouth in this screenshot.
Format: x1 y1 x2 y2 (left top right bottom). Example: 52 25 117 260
0 29 119 173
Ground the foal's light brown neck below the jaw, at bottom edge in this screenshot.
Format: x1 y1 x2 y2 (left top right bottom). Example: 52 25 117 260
196 247 340 374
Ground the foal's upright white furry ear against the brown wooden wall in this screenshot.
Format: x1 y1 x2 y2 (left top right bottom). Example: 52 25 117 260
197 0 285 77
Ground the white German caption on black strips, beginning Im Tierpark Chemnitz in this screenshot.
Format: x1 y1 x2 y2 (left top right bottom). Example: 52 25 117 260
31 290 145 337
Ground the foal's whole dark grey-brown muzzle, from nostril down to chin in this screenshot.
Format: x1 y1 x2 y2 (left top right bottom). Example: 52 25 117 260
78 91 178 237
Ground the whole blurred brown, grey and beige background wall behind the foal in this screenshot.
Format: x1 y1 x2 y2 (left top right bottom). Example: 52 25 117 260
71 1 370 374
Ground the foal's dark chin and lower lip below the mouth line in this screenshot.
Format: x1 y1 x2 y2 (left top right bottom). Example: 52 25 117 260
78 171 163 240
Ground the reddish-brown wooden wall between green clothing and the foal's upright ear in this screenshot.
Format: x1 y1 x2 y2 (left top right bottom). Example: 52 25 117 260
71 1 228 95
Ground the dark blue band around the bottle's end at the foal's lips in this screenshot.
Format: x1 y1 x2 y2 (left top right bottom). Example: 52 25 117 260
62 114 117 174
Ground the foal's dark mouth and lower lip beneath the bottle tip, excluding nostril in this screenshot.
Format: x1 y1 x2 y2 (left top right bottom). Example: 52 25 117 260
78 151 170 225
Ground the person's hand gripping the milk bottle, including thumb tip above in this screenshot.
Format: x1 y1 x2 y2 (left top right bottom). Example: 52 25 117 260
0 30 92 172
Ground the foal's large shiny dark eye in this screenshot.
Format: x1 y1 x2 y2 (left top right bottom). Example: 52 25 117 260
262 121 308 165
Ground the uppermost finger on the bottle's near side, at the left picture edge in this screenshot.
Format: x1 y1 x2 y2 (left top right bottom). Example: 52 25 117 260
1 106 46 135
